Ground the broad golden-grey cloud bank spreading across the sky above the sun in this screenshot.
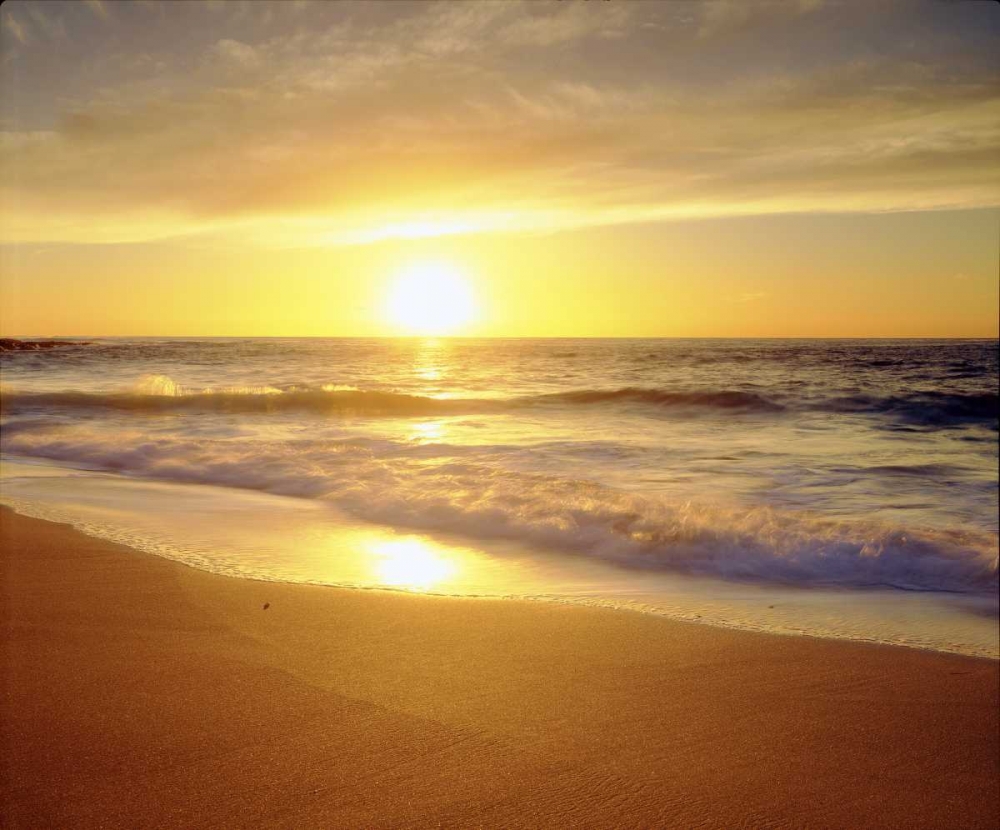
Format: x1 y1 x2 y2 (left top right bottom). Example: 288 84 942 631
0 3 1000 245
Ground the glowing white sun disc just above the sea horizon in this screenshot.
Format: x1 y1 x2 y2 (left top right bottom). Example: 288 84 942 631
386 263 476 336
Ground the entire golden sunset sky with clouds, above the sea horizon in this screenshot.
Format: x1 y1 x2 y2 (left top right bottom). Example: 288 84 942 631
0 0 1000 337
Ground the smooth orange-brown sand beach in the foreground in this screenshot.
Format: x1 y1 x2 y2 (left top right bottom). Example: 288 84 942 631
0 510 1000 830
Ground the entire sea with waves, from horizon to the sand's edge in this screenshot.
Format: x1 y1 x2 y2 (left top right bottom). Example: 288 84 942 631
0 338 1000 657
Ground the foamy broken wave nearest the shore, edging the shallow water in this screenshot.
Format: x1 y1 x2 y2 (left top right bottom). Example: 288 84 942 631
2 427 1000 592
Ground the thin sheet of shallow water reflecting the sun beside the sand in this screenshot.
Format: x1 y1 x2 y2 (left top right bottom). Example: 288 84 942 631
0 458 1000 658
